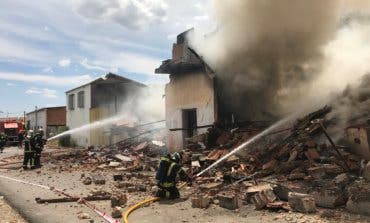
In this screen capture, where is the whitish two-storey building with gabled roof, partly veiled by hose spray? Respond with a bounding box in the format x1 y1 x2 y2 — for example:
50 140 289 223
66 73 146 147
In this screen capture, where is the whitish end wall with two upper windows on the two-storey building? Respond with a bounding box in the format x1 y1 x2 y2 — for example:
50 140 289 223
66 85 91 147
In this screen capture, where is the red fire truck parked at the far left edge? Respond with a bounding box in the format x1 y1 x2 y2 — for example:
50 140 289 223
0 118 25 145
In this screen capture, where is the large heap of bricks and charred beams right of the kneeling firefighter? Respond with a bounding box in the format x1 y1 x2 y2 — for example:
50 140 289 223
185 107 370 215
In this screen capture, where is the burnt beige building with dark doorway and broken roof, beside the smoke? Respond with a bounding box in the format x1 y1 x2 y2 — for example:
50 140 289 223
155 31 218 150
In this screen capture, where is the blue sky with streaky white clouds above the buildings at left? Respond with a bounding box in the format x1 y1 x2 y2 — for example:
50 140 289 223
0 0 215 117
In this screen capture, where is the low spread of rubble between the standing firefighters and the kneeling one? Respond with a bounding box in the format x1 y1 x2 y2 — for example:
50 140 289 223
49 135 167 171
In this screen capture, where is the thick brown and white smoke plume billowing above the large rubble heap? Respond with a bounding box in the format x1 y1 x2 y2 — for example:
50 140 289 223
190 0 370 120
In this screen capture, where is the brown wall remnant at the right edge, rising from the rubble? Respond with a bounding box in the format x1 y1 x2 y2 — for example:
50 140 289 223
346 127 370 160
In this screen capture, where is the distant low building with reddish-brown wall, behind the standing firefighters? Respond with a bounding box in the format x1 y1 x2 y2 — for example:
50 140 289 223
26 106 66 138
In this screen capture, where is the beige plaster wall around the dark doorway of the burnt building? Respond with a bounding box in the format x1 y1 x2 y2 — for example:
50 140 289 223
165 71 216 151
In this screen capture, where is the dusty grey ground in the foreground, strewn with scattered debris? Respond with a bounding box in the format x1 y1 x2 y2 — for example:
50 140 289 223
0 147 370 223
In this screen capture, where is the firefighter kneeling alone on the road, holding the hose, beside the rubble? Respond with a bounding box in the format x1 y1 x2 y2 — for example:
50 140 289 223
156 152 191 199
